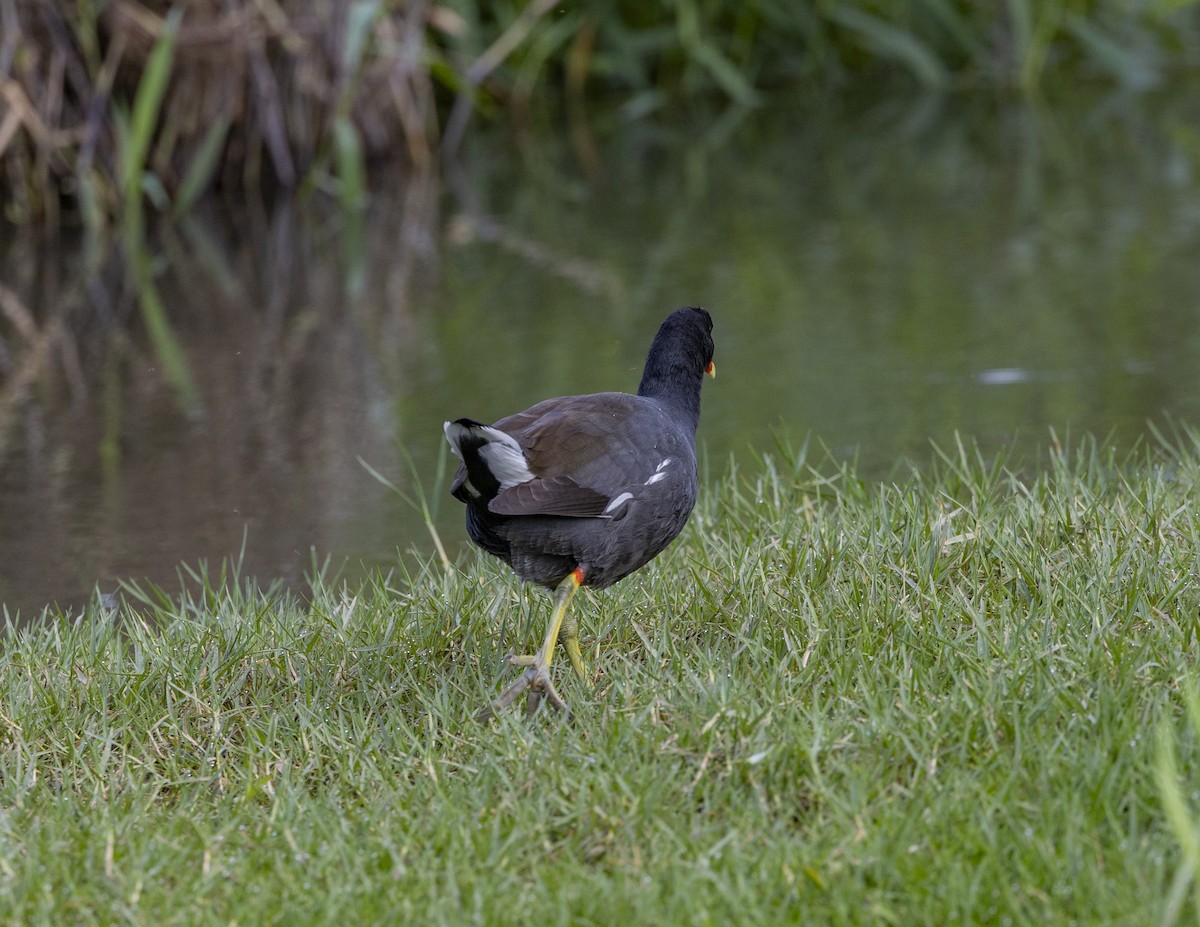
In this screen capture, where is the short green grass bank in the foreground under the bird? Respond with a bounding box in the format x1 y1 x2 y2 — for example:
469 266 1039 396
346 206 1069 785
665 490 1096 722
0 435 1200 925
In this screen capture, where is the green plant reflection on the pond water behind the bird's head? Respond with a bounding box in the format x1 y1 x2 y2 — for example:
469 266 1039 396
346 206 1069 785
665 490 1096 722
429 89 1200 472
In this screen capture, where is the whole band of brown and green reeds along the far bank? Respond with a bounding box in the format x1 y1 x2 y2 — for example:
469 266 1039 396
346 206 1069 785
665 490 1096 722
0 0 1200 228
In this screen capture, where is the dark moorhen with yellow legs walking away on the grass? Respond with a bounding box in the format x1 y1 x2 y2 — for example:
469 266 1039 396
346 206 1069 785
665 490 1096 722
443 306 716 720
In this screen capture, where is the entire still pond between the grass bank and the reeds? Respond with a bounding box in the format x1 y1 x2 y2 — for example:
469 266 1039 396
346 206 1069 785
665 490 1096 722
0 89 1200 616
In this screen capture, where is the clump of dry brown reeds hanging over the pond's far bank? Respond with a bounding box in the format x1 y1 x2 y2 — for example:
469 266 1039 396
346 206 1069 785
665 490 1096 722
0 0 436 220
